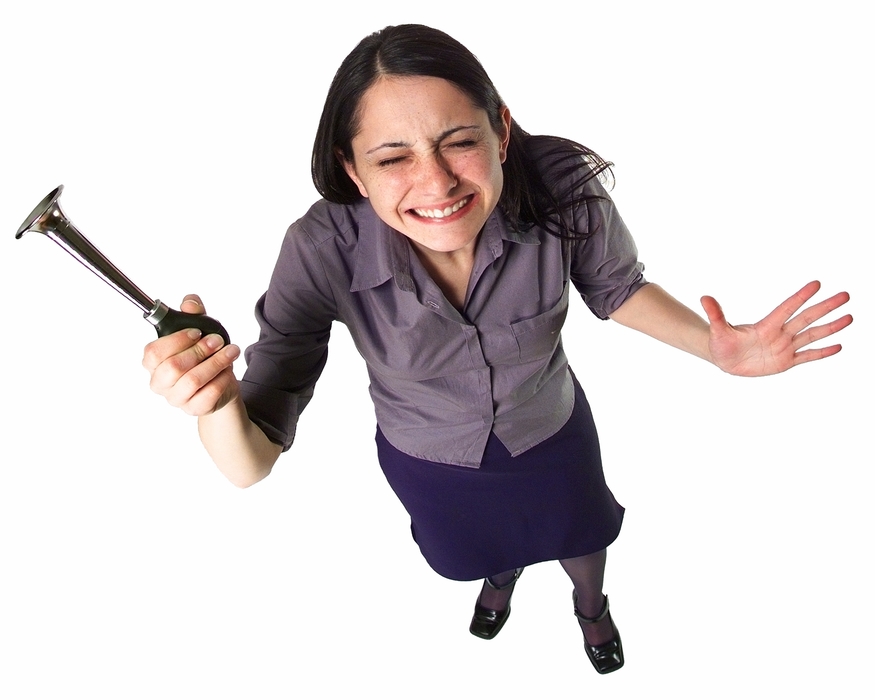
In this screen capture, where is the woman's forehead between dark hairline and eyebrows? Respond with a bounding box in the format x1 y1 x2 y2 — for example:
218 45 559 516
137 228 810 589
354 76 489 140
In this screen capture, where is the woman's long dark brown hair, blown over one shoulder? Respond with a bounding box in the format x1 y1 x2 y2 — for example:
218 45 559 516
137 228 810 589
311 24 611 238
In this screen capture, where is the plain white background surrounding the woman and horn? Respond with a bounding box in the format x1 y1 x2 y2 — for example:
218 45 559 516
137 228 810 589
0 0 875 700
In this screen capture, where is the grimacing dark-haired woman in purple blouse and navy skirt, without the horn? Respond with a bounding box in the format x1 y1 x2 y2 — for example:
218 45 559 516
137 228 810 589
144 25 851 673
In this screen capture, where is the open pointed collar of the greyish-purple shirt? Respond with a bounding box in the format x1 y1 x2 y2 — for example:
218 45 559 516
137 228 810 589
349 199 540 292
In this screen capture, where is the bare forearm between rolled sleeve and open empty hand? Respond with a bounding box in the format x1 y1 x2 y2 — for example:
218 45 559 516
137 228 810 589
611 284 712 362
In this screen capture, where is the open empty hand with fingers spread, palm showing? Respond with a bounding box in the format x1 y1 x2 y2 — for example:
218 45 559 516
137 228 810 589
702 282 853 377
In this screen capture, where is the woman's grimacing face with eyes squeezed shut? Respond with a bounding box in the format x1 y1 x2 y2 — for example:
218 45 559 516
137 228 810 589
339 76 510 253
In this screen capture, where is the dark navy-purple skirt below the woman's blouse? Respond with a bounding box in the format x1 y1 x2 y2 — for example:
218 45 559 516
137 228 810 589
376 372 624 581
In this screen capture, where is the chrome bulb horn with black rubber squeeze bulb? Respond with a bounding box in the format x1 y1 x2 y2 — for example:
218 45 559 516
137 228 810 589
15 185 231 345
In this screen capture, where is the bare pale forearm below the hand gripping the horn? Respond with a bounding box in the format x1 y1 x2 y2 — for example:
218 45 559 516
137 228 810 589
198 396 282 488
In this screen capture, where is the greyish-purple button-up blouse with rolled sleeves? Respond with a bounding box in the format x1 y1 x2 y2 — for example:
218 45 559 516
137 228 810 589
241 139 646 468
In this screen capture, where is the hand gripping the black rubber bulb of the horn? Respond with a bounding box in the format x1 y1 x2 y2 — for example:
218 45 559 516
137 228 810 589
143 294 240 416
